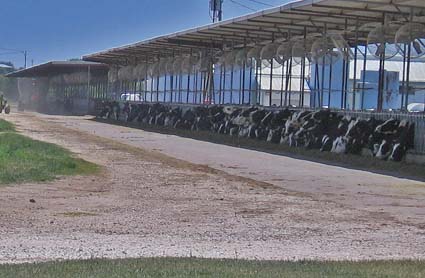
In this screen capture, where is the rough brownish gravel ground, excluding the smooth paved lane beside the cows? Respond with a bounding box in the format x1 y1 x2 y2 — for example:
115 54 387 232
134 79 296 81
0 114 425 263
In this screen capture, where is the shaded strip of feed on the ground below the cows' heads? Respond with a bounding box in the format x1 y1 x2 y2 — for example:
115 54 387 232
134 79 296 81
96 119 425 180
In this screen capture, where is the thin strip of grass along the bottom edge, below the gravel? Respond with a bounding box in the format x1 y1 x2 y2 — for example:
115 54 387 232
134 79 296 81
0 258 425 278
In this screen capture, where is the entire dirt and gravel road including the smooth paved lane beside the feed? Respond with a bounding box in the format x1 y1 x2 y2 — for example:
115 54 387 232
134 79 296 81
0 113 425 262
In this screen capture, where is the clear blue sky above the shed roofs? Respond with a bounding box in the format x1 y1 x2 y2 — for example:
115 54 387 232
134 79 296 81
0 0 289 67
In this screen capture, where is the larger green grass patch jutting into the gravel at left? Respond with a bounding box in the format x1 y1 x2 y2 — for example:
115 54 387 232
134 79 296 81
0 132 98 185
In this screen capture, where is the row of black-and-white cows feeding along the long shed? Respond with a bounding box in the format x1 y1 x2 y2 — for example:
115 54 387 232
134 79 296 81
98 102 414 161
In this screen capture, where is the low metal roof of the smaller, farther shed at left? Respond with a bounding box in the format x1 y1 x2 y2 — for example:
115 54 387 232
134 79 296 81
6 61 109 77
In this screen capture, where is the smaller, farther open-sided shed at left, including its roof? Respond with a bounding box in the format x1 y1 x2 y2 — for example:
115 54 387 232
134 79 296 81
6 61 109 113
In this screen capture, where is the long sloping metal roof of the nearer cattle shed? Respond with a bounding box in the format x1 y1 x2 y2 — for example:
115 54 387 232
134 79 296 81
83 0 425 64
